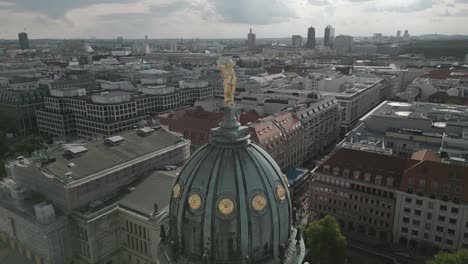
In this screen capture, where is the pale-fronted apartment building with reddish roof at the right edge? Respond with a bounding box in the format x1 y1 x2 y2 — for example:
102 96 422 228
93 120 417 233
393 155 468 254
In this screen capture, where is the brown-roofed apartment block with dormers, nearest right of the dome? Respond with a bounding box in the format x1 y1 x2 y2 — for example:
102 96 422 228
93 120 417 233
309 148 414 241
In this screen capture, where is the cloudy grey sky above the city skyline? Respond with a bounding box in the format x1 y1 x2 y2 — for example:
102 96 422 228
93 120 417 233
0 0 468 38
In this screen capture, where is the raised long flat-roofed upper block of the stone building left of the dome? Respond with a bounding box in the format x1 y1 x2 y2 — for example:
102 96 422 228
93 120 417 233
7 128 190 211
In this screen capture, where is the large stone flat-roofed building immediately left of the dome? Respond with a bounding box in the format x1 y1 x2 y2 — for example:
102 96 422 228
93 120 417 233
0 127 190 264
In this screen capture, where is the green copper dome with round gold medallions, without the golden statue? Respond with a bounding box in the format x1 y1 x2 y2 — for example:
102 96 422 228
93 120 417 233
159 107 303 264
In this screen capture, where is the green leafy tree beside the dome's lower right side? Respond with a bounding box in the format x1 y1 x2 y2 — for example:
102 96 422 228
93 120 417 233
305 216 347 264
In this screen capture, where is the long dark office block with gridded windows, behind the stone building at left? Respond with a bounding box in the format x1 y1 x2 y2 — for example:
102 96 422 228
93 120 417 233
37 79 213 139
